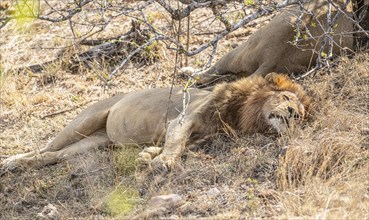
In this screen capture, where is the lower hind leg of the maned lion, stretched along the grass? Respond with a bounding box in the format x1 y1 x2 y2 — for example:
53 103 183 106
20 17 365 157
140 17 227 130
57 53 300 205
2 129 110 170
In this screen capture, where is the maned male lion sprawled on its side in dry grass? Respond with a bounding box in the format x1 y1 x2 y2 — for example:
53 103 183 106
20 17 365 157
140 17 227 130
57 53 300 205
2 73 311 170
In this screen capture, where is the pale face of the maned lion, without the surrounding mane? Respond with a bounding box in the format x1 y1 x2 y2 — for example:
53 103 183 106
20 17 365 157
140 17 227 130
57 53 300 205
263 91 305 133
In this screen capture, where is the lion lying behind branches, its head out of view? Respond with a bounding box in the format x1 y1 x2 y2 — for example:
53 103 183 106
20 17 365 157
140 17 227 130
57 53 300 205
196 0 354 85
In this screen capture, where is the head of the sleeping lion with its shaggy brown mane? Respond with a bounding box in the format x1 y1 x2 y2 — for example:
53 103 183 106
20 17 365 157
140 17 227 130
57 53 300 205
210 73 311 133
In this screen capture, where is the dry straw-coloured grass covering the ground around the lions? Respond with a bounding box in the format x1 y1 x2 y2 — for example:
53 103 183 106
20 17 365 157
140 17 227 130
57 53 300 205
0 0 369 219
